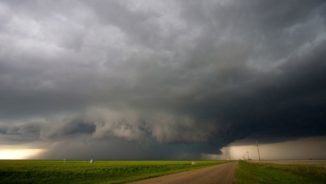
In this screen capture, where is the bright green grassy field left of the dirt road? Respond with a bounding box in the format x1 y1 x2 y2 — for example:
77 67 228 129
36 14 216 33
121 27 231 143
0 160 226 184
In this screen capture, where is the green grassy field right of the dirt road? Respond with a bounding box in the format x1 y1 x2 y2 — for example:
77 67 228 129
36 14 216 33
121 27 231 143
235 161 326 184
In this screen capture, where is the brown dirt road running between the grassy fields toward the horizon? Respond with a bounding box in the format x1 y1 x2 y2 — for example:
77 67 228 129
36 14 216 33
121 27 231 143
132 162 237 184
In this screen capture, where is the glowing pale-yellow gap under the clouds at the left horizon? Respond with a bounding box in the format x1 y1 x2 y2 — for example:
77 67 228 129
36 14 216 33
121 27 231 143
0 148 45 160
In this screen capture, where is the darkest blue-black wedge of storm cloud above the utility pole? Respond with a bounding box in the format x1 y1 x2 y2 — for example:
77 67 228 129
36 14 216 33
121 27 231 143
200 40 326 142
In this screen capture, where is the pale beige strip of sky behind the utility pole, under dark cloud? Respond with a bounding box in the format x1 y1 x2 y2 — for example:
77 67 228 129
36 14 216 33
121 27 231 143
219 136 326 160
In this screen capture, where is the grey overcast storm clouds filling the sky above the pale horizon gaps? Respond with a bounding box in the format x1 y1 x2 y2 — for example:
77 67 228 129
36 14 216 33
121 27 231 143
0 0 326 159
